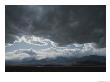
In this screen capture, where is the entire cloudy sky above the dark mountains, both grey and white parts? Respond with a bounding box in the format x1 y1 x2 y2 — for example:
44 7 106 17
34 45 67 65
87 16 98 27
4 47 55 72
5 5 106 63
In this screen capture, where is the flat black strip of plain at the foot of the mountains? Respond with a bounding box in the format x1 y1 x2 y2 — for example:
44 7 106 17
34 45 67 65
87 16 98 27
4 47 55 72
5 65 106 72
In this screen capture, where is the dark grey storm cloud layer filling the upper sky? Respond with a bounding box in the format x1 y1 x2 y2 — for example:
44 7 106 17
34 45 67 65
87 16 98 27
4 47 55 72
5 5 106 47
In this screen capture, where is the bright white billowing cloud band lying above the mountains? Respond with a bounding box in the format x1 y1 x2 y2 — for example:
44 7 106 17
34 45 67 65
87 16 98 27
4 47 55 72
5 35 106 62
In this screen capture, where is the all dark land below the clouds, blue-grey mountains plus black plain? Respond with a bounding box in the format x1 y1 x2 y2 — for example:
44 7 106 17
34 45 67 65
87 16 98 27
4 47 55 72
5 56 106 72
